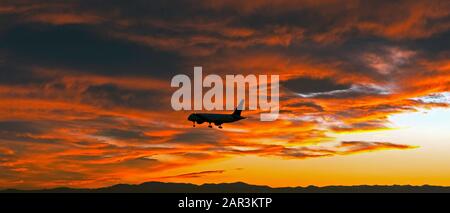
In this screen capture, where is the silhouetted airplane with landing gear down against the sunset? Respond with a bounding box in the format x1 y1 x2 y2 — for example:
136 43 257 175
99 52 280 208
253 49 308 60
188 100 245 129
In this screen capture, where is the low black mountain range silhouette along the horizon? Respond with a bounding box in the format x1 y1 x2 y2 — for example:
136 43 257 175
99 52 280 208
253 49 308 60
0 182 450 193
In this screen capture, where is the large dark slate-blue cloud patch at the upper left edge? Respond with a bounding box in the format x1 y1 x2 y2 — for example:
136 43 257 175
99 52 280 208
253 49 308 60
0 24 179 77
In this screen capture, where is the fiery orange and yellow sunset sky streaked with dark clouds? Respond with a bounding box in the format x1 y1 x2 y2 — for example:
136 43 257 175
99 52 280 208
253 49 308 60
0 0 450 189
